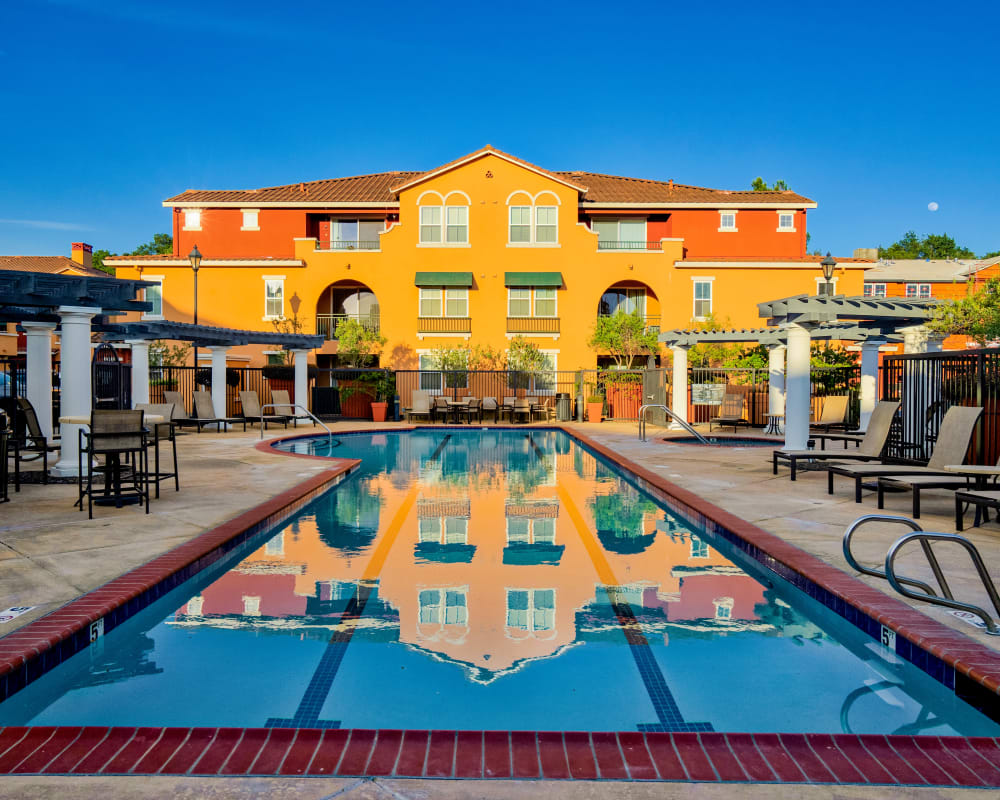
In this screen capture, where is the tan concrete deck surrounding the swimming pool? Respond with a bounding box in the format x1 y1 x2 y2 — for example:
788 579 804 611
0 423 997 797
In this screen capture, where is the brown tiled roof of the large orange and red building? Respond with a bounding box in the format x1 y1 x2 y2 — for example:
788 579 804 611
163 145 816 208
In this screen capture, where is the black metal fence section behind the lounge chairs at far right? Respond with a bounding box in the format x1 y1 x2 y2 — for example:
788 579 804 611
882 348 1000 464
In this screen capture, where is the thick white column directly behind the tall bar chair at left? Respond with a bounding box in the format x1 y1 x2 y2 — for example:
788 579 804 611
51 306 101 476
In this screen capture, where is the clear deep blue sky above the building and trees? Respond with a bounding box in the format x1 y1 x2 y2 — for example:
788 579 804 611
0 0 1000 255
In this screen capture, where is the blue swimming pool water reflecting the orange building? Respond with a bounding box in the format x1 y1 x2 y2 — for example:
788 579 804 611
0 428 1000 736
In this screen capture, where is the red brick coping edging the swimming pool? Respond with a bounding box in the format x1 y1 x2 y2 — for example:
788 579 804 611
0 425 1000 787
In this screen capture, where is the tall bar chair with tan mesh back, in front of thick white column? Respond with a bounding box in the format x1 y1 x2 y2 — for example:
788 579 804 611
77 408 149 519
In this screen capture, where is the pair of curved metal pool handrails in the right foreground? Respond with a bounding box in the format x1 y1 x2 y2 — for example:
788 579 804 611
844 514 1000 636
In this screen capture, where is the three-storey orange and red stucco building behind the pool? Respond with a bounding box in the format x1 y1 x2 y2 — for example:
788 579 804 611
106 146 870 370
